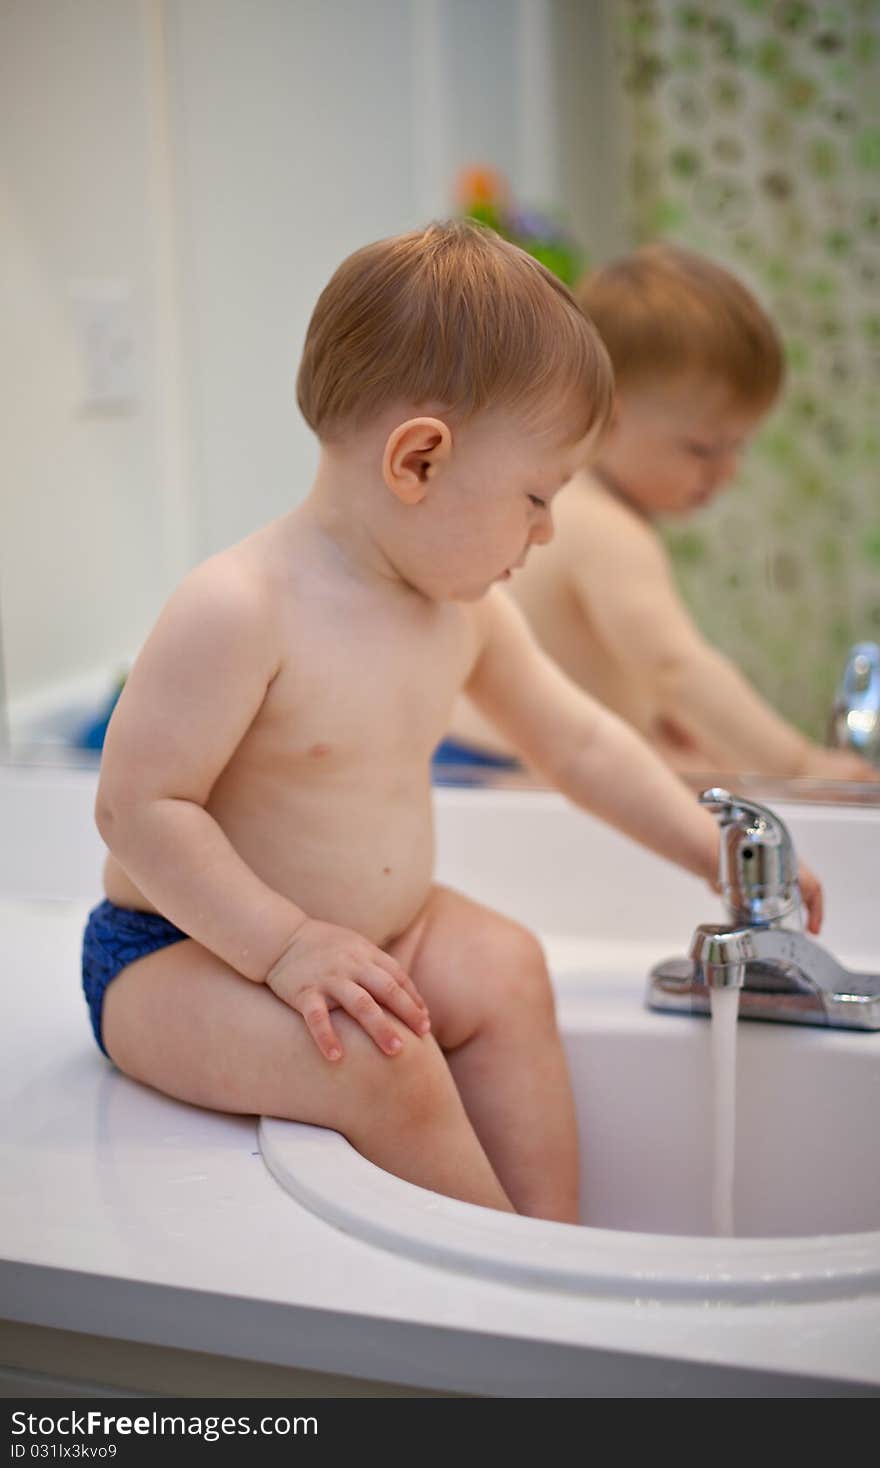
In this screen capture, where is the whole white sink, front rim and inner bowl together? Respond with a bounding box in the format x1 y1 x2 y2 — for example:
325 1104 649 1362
260 944 880 1302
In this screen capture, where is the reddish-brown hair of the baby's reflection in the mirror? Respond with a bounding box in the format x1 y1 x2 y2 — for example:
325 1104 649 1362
574 242 785 411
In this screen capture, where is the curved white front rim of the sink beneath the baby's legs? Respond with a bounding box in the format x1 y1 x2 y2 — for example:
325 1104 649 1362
257 1117 880 1304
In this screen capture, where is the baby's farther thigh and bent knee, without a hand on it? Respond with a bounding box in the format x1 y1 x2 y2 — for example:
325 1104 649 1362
388 885 555 1050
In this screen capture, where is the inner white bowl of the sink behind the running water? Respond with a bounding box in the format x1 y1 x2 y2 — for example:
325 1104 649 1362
563 974 880 1239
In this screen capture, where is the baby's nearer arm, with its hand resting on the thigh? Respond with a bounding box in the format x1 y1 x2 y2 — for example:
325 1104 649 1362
95 556 425 1058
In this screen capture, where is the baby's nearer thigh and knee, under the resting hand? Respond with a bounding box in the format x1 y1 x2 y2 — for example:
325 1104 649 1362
103 940 452 1136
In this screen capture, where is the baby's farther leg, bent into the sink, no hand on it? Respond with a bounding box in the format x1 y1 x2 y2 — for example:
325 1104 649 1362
389 887 579 1223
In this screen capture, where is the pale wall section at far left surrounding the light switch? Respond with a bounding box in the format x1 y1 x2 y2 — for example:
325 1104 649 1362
0 0 166 728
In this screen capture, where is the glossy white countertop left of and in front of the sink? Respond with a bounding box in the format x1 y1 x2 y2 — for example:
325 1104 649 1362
0 898 880 1398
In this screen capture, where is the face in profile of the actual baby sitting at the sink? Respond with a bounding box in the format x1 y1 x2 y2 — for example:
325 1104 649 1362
417 413 591 602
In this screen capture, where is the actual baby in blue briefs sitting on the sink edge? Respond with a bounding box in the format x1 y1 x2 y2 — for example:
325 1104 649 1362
84 222 820 1221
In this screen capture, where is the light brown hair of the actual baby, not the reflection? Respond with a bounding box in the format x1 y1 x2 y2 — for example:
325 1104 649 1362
297 220 614 442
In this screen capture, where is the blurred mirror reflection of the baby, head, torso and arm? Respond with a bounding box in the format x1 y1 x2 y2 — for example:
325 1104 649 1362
444 244 877 780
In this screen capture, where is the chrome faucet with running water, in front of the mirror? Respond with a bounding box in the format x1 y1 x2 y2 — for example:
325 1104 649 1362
646 788 880 1029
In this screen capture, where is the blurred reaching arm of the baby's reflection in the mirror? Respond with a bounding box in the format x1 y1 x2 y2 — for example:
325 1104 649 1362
563 502 876 780
